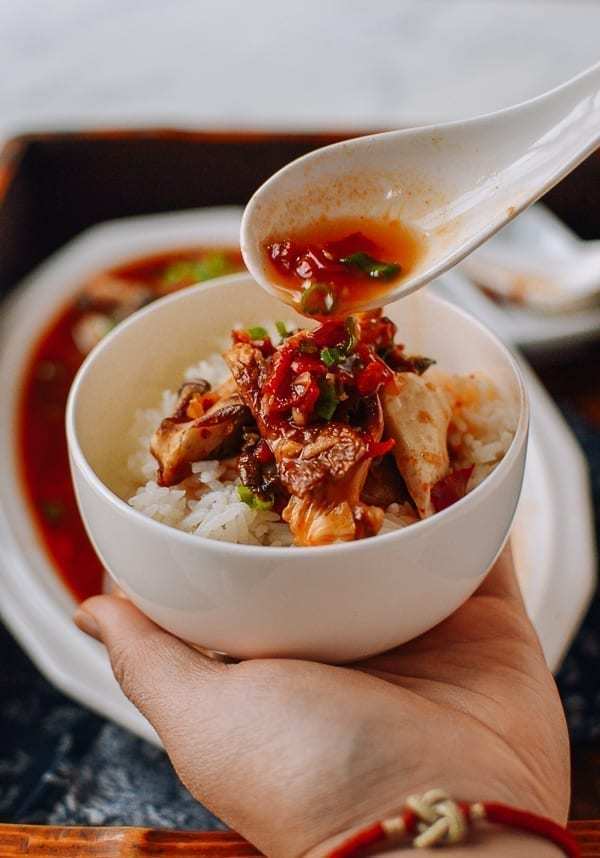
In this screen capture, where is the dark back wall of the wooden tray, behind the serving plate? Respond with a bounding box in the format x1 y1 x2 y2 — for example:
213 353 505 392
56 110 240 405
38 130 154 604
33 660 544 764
0 129 600 294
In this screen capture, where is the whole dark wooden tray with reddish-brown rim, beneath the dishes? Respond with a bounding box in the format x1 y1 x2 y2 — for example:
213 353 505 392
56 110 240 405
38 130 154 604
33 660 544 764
0 129 600 858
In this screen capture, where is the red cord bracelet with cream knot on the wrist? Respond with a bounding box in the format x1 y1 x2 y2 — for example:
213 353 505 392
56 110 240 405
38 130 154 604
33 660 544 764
327 789 581 858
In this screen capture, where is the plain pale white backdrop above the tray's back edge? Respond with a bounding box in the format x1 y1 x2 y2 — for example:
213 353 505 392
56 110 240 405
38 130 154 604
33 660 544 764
0 0 600 137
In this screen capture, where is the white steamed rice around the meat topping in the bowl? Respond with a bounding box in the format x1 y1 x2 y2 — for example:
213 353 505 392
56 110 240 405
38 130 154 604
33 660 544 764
127 348 517 546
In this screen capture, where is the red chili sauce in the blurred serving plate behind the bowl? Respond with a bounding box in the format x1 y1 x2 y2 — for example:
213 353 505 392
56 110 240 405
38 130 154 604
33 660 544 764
17 248 243 600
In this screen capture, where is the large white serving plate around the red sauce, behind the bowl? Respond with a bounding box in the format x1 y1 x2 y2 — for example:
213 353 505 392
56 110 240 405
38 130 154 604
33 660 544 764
0 209 595 742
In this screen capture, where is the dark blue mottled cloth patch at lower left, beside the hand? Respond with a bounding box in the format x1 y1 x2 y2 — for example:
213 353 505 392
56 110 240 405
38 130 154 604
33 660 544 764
0 626 223 829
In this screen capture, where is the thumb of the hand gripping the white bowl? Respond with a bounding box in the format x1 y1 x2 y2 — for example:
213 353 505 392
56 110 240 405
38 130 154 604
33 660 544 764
74 596 228 741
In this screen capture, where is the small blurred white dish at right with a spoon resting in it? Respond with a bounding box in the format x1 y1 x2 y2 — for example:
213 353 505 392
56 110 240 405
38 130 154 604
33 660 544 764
447 204 600 353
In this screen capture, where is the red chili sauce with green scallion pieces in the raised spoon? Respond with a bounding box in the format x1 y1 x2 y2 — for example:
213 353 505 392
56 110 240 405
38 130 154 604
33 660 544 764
264 218 423 318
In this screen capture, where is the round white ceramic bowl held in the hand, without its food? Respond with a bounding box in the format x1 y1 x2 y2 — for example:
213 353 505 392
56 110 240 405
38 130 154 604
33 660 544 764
67 274 528 662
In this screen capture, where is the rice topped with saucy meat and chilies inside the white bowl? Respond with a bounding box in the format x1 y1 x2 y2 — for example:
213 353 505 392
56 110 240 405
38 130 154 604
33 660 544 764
128 311 518 546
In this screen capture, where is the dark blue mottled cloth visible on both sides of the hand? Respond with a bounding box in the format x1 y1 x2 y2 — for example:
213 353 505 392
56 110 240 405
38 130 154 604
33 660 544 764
0 407 600 829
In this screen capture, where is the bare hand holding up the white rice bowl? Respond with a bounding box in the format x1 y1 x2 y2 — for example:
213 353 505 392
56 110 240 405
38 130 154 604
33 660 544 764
76 552 569 856
